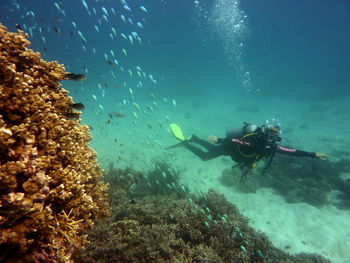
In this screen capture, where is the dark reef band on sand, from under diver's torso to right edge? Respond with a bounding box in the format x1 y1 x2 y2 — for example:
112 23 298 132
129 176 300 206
219 155 350 209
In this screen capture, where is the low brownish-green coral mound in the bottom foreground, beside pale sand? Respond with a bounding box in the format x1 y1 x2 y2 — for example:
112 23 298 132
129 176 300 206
73 165 330 263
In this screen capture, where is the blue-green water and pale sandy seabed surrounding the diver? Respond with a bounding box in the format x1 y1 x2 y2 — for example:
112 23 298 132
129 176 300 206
0 0 350 263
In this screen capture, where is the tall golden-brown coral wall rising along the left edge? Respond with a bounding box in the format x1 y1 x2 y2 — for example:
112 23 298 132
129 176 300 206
0 24 108 262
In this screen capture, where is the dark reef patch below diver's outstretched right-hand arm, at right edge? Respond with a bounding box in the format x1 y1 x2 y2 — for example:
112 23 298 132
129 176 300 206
260 156 350 208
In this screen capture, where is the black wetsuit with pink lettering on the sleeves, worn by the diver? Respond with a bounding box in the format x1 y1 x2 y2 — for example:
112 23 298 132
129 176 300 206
183 133 316 165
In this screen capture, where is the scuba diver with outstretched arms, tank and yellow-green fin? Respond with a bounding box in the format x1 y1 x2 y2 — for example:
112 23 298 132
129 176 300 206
168 119 326 182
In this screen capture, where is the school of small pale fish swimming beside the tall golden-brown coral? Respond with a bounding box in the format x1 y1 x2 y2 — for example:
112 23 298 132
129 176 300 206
0 0 177 159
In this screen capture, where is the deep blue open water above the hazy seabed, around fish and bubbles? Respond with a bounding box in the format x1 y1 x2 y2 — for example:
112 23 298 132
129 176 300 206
1 0 350 98
